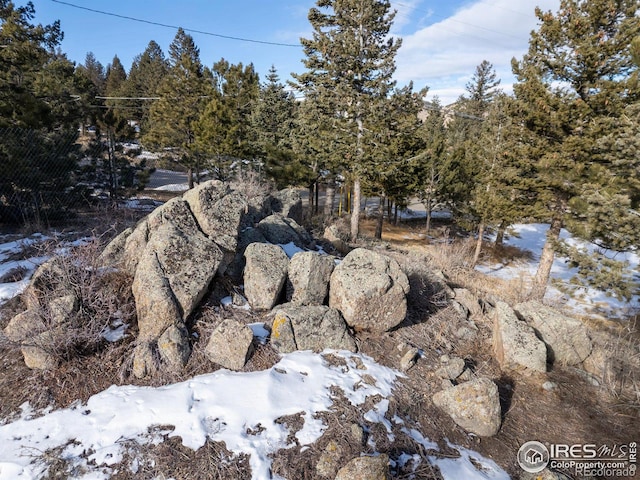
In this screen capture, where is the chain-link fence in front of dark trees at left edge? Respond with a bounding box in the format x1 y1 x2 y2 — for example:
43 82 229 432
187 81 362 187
0 128 148 226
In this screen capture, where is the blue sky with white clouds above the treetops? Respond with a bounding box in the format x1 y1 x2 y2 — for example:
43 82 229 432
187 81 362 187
31 0 559 104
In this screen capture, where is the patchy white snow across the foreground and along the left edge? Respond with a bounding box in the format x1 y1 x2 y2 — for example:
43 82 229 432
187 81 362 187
0 234 509 480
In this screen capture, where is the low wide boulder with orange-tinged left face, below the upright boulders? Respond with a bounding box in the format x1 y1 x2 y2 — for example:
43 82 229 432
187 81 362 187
271 303 356 353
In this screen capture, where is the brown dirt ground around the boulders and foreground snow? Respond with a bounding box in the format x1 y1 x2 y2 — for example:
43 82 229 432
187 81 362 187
0 208 640 479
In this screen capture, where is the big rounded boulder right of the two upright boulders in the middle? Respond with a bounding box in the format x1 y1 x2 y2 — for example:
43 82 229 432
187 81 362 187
329 248 409 332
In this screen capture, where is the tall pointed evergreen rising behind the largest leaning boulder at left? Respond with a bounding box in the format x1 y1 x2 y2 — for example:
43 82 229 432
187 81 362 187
142 29 211 188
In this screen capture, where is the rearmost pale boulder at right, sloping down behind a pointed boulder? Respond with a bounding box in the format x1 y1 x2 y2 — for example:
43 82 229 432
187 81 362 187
514 301 593 365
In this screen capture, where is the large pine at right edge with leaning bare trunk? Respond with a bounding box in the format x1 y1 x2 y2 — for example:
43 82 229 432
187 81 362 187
513 0 640 298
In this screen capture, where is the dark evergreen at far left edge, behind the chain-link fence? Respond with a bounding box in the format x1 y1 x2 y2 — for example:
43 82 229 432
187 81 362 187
0 0 83 221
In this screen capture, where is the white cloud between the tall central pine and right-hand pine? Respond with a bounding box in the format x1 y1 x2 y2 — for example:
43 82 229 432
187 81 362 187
395 0 559 104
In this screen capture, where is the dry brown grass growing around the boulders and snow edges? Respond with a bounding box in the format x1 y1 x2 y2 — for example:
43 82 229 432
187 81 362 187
0 211 640 480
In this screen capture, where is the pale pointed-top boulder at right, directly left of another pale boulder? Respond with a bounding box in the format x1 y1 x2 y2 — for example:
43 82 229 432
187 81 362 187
493 302 547 373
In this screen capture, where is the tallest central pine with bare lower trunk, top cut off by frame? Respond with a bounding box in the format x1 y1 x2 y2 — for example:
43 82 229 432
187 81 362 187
294 0 400 240
